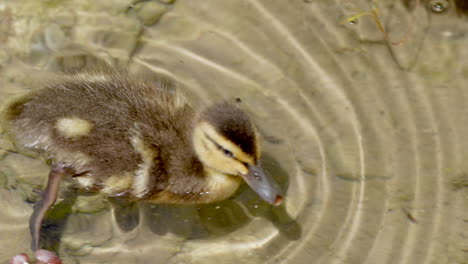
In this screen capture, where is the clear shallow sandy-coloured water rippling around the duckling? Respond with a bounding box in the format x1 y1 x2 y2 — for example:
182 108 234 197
0 0 468 263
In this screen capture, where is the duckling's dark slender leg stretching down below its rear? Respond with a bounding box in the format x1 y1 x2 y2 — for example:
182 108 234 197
29 164 73 252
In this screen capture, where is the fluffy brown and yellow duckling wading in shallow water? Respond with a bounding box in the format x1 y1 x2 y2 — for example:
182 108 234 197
5 71 283 252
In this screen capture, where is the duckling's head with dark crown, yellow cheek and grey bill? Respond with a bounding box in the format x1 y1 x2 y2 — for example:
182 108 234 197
193 103 283 205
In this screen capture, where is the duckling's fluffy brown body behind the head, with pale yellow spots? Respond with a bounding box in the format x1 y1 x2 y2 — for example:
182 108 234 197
7 72 193 197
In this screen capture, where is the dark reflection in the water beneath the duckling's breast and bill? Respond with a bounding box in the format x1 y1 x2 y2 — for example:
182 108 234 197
113 155 302 240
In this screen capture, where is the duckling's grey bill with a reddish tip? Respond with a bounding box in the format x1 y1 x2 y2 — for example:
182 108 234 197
242 165 283 205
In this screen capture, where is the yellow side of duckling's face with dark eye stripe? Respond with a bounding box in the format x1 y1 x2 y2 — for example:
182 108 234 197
193 122 255 175
